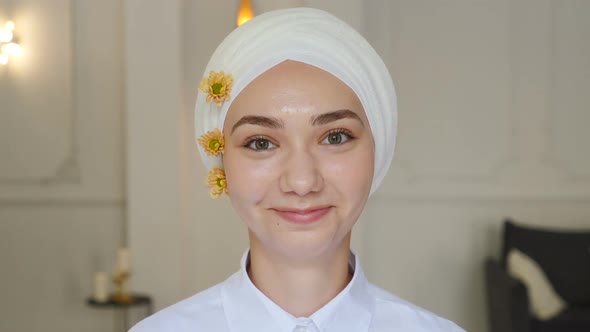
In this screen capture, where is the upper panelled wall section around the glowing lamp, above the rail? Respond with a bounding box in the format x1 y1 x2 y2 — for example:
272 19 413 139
0 0 125 202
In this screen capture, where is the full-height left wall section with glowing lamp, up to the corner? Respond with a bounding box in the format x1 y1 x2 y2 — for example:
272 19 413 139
0 0 125 332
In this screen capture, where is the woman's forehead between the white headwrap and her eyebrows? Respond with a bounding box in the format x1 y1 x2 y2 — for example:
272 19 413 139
226 60 366 122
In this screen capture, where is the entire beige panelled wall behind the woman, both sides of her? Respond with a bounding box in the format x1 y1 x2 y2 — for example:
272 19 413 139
0 0 590 332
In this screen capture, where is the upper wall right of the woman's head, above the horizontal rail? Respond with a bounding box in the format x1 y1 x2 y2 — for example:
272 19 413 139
364 0 590 200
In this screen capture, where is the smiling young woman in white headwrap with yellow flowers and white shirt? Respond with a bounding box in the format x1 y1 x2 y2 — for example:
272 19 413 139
131 8 463 332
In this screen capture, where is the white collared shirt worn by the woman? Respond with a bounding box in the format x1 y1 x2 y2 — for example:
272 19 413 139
129 251 465 332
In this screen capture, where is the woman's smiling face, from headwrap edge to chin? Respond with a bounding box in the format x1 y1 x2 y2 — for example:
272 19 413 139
223 61 374 259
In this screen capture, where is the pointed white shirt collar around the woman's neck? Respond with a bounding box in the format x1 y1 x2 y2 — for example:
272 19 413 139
222 250 373 332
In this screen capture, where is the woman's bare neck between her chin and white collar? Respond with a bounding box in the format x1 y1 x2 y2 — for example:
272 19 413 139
248 233 352 317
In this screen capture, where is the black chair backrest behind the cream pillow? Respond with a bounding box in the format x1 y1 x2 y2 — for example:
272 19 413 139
502 219 590 305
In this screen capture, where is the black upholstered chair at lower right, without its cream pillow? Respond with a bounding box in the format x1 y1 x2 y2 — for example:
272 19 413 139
485 219 590 332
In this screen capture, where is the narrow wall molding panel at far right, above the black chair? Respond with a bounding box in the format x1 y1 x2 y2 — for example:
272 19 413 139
543 0 590 183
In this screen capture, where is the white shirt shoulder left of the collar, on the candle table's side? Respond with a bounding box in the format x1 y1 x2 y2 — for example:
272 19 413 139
129 274 232 332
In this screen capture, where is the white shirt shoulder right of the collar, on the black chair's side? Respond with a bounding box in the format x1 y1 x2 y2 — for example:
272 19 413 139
367 283 465 332
